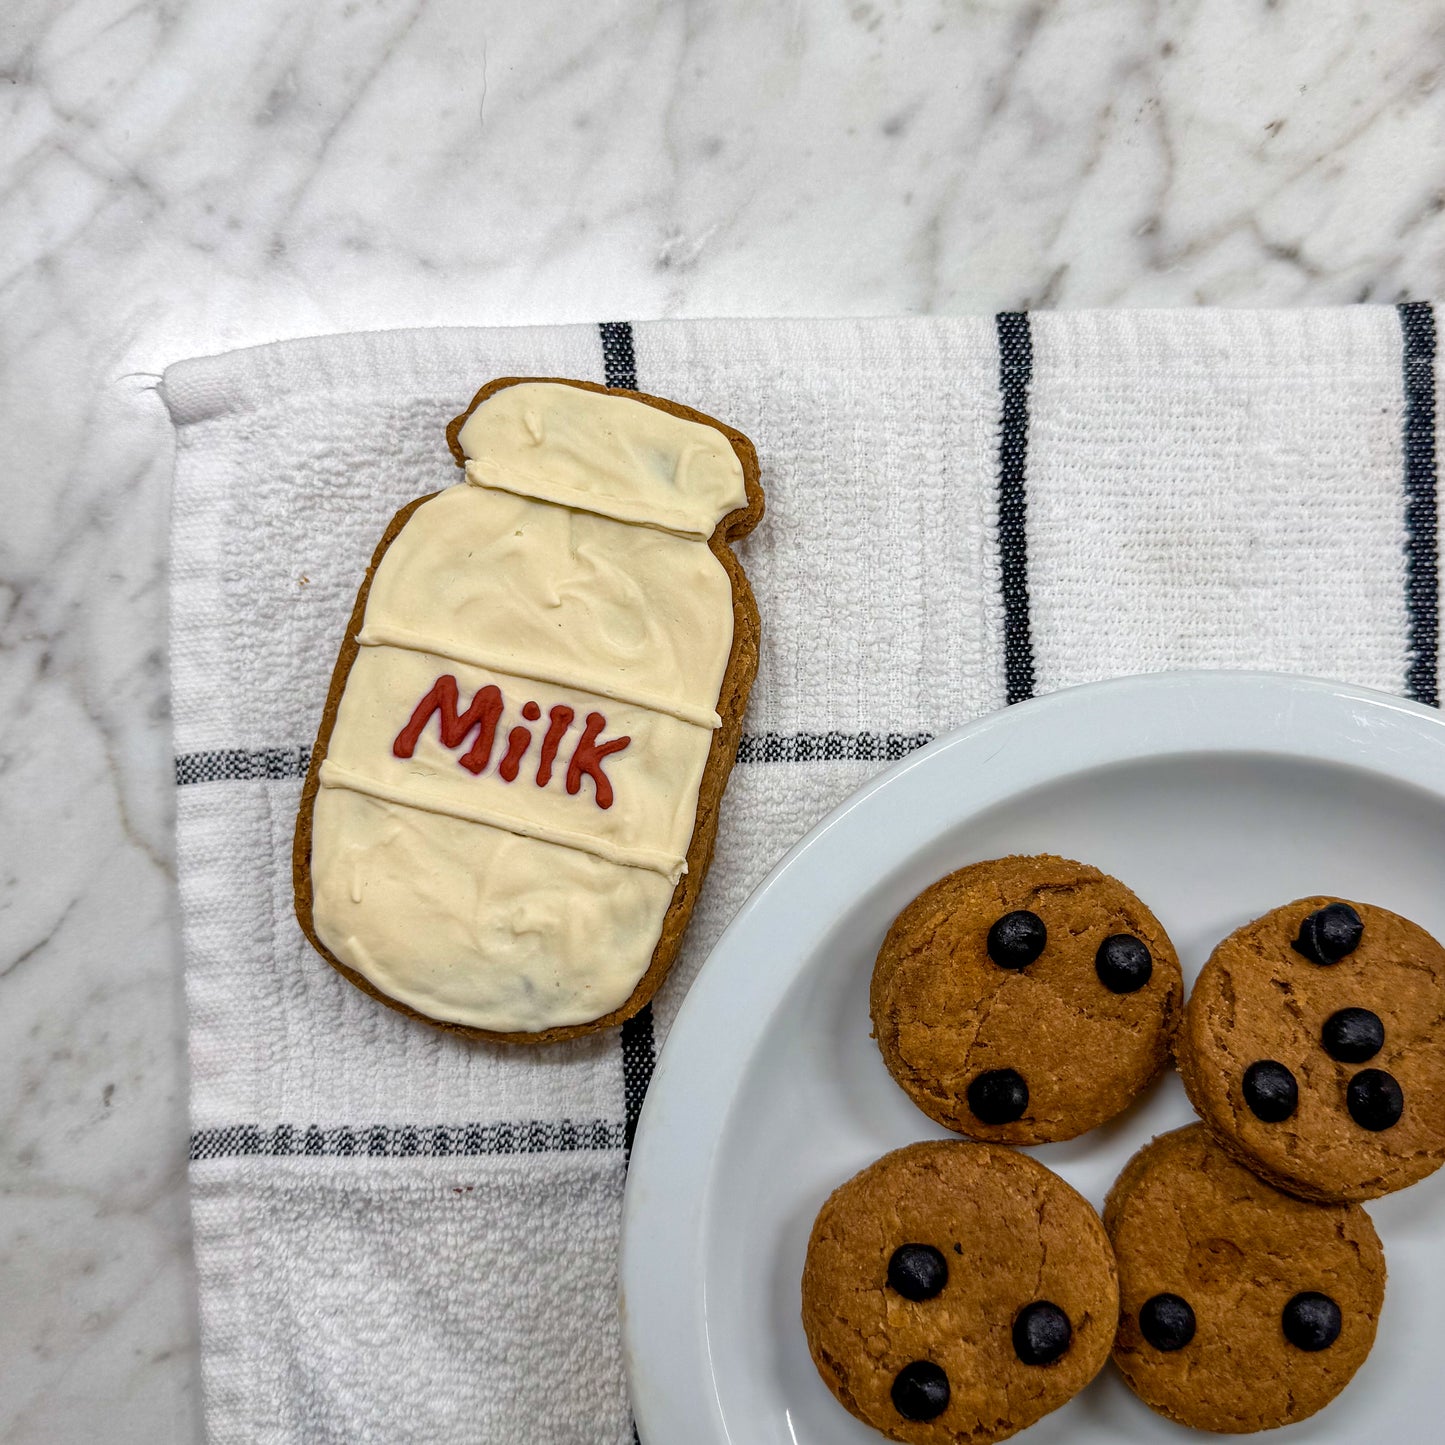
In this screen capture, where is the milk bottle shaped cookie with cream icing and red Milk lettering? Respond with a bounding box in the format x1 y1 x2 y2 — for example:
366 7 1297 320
295 379 763 1042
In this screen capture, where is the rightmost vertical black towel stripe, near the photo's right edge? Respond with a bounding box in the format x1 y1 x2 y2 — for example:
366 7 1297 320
1397 301 1441 707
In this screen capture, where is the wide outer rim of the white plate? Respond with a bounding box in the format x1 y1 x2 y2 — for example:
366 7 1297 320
618 670 1445 1445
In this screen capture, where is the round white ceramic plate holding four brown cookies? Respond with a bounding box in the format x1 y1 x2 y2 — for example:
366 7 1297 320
621 673 1445 1445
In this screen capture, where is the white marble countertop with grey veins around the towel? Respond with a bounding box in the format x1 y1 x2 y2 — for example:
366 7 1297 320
0 0 1445 1445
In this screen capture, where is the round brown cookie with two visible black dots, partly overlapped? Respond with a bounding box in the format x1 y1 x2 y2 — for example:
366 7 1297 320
1104 1124 1384 1435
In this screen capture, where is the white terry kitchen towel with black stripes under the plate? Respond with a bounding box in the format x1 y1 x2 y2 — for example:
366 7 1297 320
163 305 1442 1445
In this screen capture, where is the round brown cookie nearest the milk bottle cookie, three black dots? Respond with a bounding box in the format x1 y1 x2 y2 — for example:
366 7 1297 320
870 855 1183 1144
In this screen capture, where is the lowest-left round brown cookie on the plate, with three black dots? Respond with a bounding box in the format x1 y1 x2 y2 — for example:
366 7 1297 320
802 1140 1118 1445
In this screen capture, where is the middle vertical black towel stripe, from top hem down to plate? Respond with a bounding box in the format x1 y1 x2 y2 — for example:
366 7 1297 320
994 311 1033 702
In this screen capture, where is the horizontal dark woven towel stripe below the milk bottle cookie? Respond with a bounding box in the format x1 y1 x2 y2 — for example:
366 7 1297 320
191 1118 623 1159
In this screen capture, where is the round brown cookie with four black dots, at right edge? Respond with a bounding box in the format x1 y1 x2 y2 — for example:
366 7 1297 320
1179 897 1445 1199
